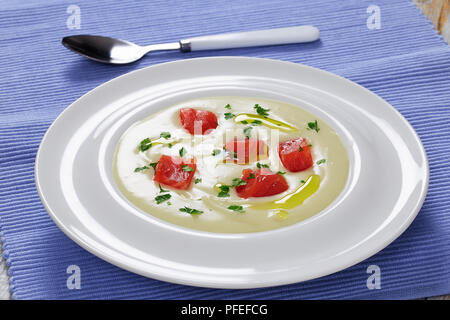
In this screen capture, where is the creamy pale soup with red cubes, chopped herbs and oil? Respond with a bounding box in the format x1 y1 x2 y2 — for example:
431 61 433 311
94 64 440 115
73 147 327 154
113 97 349 233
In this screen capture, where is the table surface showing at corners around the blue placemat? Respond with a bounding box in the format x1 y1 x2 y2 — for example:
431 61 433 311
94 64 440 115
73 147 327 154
0 0 450 300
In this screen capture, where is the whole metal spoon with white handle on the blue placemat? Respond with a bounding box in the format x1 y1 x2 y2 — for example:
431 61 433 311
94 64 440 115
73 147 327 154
62 26 319 64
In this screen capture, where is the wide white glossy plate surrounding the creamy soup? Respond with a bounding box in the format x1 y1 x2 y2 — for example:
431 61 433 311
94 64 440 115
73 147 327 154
35 57 429 288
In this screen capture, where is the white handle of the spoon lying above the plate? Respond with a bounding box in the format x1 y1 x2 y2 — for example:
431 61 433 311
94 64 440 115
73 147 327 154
180 26 320 51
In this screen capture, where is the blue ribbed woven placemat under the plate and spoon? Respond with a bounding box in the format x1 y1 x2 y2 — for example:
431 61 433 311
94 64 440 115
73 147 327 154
0 0 450 299
